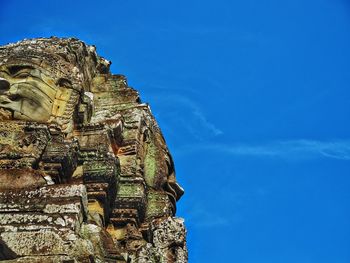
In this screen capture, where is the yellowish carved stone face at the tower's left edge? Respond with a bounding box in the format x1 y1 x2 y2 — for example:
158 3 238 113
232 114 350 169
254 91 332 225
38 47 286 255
0 65 59 122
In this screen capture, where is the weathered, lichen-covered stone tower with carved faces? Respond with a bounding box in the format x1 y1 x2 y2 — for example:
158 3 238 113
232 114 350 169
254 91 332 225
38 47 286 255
0 37 187 263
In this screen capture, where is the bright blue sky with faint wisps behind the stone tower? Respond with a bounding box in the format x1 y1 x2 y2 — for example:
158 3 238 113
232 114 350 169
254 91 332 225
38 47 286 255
0 0 350 263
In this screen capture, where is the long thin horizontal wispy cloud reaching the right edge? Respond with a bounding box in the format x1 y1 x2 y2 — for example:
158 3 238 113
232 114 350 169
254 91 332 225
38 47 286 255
174 139 350 160
